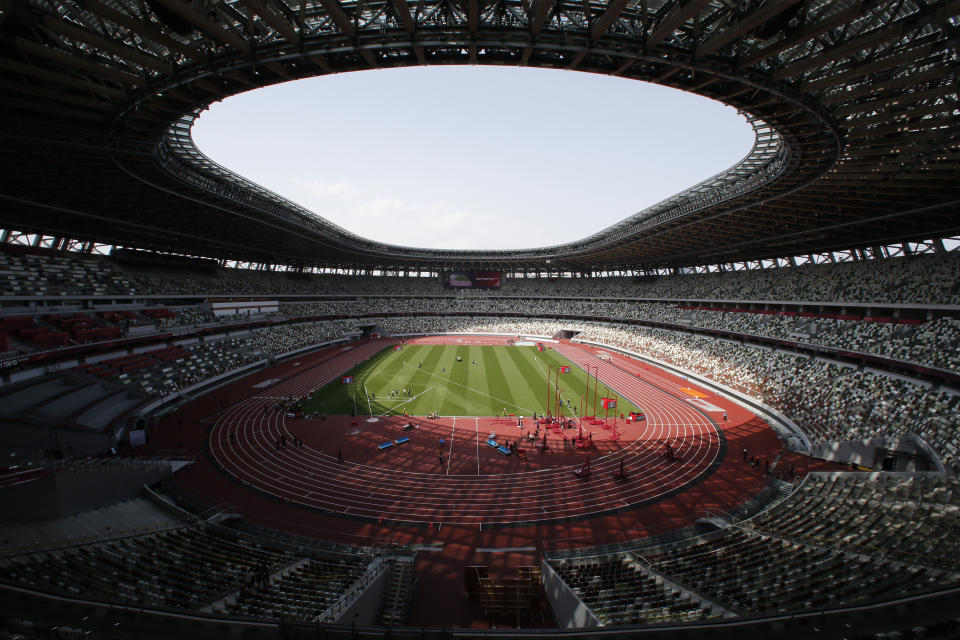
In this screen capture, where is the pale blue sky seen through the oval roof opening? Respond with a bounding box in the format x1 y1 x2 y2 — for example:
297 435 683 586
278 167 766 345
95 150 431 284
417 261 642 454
193 66 753 249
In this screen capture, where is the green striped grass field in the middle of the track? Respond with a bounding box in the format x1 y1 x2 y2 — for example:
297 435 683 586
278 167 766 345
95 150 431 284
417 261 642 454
303 345 636 416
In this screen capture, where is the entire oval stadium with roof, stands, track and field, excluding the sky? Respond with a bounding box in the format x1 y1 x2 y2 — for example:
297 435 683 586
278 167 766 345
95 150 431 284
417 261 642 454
0 0 960 639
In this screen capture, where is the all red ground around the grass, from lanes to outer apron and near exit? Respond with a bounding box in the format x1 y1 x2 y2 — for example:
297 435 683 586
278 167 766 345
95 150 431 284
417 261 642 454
145 336 840 626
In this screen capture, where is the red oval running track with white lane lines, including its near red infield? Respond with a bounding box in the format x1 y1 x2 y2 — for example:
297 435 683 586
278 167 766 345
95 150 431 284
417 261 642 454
209 338 724 529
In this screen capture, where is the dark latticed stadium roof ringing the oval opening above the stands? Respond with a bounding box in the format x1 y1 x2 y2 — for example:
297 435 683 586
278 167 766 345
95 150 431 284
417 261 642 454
0 0 960 271
